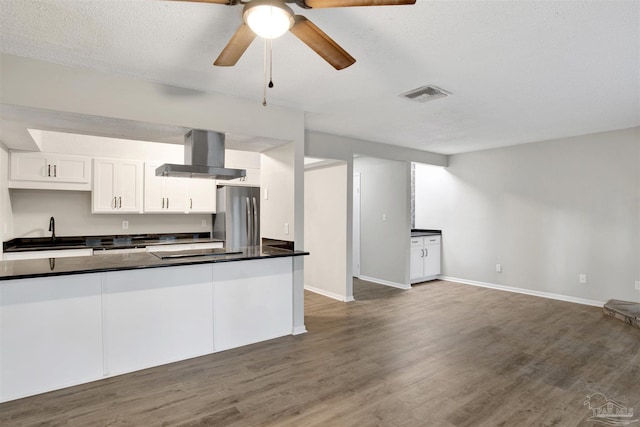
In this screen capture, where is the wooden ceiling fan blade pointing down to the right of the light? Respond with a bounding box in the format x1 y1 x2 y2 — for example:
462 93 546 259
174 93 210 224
290 15 356 70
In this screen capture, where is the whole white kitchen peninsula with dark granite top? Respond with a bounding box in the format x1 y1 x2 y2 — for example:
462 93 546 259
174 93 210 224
0 245 308 401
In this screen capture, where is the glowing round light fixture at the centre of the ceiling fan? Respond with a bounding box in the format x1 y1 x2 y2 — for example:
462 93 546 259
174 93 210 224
242 0 294 39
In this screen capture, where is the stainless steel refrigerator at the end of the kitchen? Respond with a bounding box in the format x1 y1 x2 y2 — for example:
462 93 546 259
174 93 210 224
213 185 260 251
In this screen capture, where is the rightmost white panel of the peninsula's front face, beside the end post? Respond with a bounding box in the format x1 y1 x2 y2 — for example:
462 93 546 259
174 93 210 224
213 258 293 351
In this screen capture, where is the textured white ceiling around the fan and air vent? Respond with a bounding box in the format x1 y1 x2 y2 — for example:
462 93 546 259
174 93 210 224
0 0 640 154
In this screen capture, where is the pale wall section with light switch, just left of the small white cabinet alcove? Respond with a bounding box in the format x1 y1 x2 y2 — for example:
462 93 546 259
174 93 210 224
353 157 411 288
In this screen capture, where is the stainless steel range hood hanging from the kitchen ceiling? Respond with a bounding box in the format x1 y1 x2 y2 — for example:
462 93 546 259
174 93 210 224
156 129 247 180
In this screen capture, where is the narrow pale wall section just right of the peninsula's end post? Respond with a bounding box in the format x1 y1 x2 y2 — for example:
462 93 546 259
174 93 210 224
304 163 353 301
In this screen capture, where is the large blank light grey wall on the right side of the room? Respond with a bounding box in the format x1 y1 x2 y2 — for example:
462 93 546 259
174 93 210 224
416 128 640 301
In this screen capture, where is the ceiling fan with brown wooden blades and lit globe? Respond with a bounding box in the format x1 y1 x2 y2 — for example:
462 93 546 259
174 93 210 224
166 0 416 70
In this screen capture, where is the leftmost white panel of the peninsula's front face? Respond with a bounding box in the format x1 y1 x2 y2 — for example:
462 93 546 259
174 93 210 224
0 274 104 401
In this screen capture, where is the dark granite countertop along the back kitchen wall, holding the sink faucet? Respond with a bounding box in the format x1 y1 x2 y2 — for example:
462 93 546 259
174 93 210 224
3 232 222 252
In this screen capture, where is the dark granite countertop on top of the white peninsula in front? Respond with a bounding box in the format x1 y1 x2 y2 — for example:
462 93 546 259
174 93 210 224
0 246 309 281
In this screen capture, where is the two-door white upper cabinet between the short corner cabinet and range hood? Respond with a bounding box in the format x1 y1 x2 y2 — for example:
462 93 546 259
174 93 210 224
91 159 144 213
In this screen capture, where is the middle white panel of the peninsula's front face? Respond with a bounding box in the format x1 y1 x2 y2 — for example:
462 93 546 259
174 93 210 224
104 264 213 375
